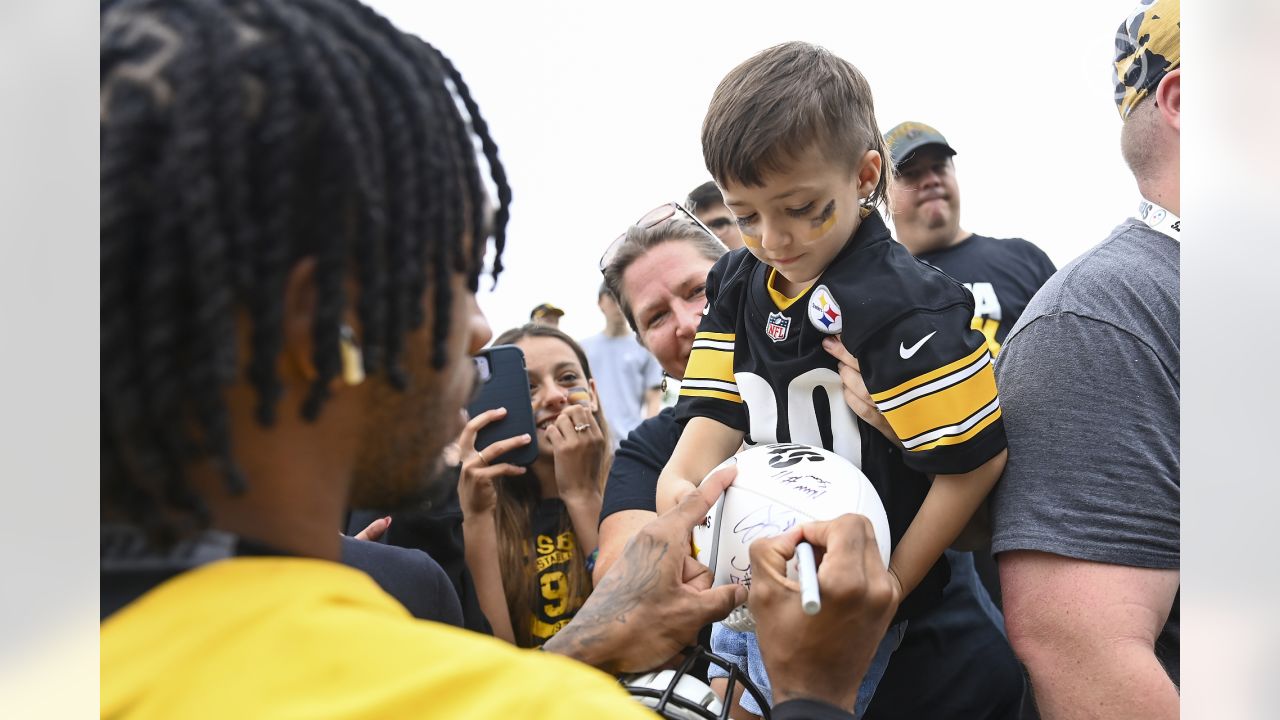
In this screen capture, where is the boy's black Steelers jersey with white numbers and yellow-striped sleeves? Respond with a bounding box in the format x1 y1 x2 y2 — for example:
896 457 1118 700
677 213 1005 476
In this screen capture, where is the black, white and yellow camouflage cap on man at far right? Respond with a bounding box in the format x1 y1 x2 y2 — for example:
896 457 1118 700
1112 0 1181 119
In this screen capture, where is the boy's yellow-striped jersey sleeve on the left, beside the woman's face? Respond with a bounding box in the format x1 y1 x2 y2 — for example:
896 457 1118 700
676 254 748 432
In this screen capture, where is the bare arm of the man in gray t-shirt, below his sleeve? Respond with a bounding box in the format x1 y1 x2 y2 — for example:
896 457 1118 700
1000 551 1179 720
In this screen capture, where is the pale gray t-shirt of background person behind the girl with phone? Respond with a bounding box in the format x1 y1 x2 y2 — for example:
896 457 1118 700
580 333 662 450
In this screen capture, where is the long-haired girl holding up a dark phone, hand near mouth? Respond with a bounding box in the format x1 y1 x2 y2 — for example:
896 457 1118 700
458 324 612 647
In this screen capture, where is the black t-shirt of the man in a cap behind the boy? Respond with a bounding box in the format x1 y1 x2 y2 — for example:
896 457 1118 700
918 234 1056 355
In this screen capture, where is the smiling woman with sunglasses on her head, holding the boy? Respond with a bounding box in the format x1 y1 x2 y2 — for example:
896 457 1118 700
595 202 1023 720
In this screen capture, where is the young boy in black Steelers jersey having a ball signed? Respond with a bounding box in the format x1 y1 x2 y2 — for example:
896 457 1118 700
658 42 1006 715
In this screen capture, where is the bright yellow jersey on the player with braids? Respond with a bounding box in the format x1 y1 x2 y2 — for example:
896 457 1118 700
101 557 653 720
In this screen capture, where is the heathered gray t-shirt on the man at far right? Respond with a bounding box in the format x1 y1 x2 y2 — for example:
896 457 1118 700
992 219 1180 684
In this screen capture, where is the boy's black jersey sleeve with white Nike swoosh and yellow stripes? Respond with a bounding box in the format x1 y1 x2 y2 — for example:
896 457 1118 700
858 304 1005 474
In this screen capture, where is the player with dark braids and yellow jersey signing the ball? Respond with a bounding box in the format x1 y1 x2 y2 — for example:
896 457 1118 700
100 0 895 719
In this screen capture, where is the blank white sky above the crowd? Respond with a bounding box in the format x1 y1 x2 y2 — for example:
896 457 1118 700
370 0 1138 337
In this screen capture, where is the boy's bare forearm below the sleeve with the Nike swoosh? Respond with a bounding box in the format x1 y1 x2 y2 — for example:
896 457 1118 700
888 450 1009 597
